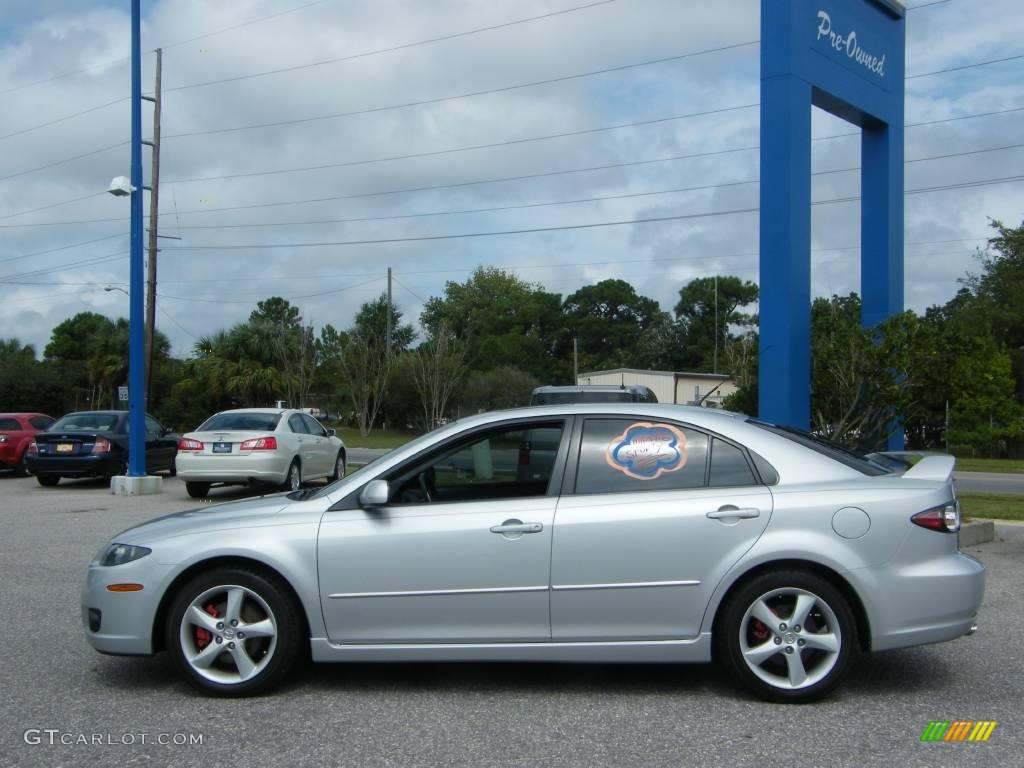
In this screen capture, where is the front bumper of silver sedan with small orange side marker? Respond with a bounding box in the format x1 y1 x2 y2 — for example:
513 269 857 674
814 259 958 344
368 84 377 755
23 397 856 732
82 554 170 656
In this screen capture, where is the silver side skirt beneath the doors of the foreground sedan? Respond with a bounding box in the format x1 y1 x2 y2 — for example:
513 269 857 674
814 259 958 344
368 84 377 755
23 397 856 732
309 632 712 664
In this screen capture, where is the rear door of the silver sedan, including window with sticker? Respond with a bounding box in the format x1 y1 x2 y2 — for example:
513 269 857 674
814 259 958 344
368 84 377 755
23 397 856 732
551 417 772 641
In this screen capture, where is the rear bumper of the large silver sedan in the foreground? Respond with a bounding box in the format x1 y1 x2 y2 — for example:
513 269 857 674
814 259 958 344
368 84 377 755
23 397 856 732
848 552 985 650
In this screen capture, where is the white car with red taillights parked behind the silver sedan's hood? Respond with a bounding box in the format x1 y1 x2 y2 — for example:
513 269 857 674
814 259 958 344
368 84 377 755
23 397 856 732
177 408 345 499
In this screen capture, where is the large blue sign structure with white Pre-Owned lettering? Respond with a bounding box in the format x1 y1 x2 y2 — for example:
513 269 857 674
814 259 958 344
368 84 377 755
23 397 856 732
759 0 905 450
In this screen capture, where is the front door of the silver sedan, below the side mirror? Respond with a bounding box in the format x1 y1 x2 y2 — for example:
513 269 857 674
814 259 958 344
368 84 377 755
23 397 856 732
317 418 568 643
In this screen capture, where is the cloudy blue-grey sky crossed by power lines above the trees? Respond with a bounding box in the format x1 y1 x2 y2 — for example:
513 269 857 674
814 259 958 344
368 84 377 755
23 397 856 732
0 0 1024 355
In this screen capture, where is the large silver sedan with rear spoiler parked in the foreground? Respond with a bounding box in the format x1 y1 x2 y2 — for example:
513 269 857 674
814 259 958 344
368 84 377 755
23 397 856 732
82 403 984 701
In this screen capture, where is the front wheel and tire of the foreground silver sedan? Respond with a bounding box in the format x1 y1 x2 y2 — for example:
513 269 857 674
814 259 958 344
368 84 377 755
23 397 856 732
165 567 308 696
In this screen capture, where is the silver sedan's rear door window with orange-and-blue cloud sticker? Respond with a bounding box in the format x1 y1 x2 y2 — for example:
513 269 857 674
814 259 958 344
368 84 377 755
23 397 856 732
575 419 708 494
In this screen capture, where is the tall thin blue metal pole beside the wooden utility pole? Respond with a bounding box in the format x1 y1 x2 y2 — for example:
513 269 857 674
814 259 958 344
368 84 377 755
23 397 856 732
128 0 145 477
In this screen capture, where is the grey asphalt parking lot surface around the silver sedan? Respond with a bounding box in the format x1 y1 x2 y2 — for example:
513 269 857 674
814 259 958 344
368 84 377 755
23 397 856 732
0 475 1024 768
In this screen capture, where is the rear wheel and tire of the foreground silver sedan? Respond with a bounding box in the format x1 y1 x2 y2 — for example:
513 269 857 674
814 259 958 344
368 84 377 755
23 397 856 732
715 570 857 703
